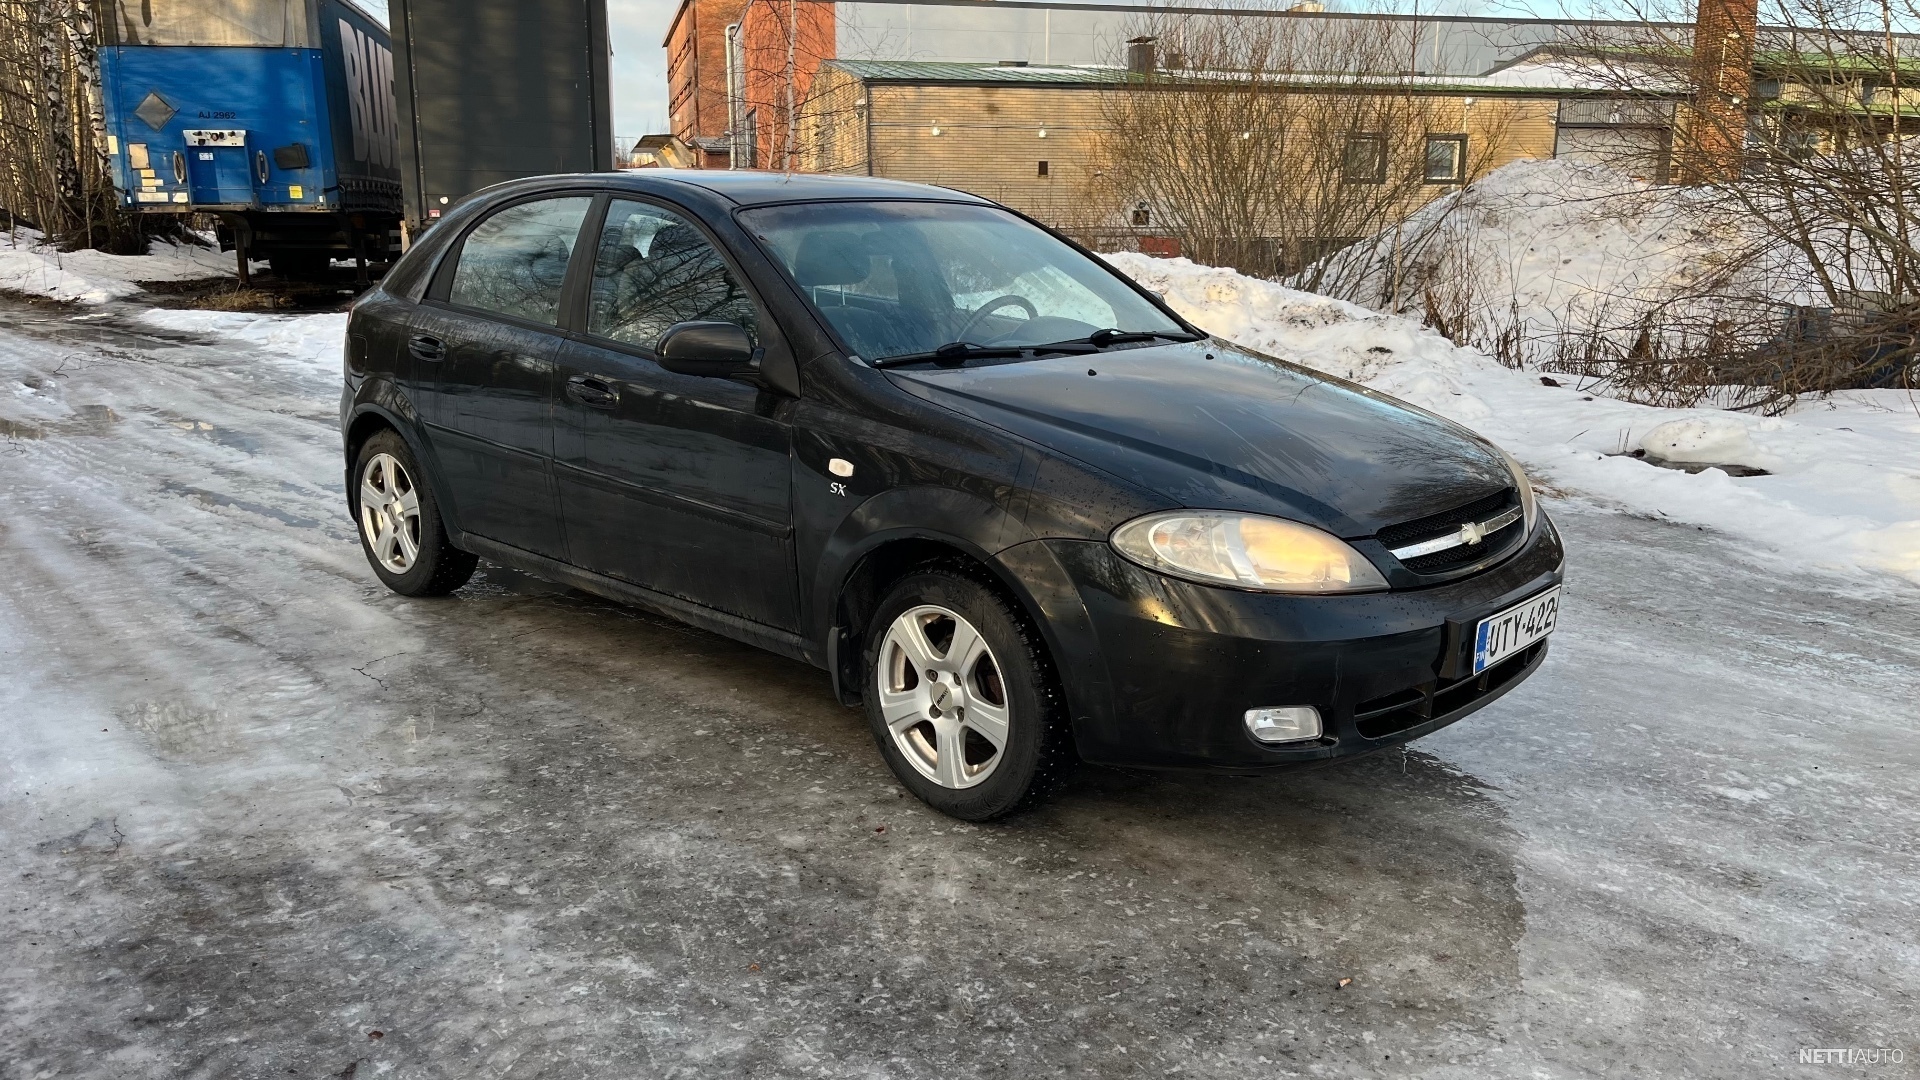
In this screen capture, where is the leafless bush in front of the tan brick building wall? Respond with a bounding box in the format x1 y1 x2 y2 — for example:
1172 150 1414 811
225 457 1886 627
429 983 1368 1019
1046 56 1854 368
1092 10 1513 288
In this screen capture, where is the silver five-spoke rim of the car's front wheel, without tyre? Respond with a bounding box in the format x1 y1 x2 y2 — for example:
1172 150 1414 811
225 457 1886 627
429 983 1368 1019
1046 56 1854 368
876 603 1012 790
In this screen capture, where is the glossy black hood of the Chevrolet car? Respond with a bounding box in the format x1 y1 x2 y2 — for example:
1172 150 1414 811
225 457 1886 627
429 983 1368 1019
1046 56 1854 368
887 340 1513 540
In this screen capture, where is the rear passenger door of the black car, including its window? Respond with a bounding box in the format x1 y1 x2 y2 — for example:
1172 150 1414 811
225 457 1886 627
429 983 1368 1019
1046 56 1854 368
407 194 593 559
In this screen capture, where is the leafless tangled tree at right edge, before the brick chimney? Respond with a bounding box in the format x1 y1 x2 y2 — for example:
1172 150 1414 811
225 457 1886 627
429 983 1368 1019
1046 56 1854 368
1543 0 1920 409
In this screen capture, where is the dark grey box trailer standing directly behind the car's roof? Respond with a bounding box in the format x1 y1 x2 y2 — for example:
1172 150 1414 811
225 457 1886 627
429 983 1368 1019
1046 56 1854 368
390 0 612 231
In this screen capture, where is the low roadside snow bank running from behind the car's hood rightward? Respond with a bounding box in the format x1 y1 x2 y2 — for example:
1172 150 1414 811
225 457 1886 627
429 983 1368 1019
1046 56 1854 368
1104 252 1920 580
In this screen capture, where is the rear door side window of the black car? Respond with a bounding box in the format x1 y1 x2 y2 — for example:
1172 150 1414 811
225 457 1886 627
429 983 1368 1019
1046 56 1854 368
447 196 593 327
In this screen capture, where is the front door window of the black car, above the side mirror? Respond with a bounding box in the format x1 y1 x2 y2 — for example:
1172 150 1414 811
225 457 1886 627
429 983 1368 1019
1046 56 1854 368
588 198 758 350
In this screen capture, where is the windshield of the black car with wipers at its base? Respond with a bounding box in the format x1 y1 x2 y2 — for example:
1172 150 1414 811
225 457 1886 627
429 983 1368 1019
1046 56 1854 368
741 202 1190 361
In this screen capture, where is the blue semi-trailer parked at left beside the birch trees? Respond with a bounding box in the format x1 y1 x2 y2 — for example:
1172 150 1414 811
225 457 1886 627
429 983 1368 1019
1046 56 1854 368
96 0 401 277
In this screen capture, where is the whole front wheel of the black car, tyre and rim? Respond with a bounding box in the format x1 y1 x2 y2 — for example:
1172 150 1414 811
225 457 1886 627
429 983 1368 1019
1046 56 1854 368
864 569 1069 821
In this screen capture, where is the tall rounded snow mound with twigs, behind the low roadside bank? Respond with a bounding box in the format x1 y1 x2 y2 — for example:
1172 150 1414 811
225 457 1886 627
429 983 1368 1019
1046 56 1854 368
1296 160 1820 365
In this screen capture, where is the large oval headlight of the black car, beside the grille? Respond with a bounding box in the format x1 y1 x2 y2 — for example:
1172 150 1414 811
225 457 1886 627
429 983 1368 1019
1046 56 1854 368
1114 509 1386 592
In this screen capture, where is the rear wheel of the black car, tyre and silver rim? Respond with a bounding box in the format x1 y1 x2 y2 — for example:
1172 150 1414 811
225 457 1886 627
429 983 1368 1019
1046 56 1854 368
353 429 480 596
